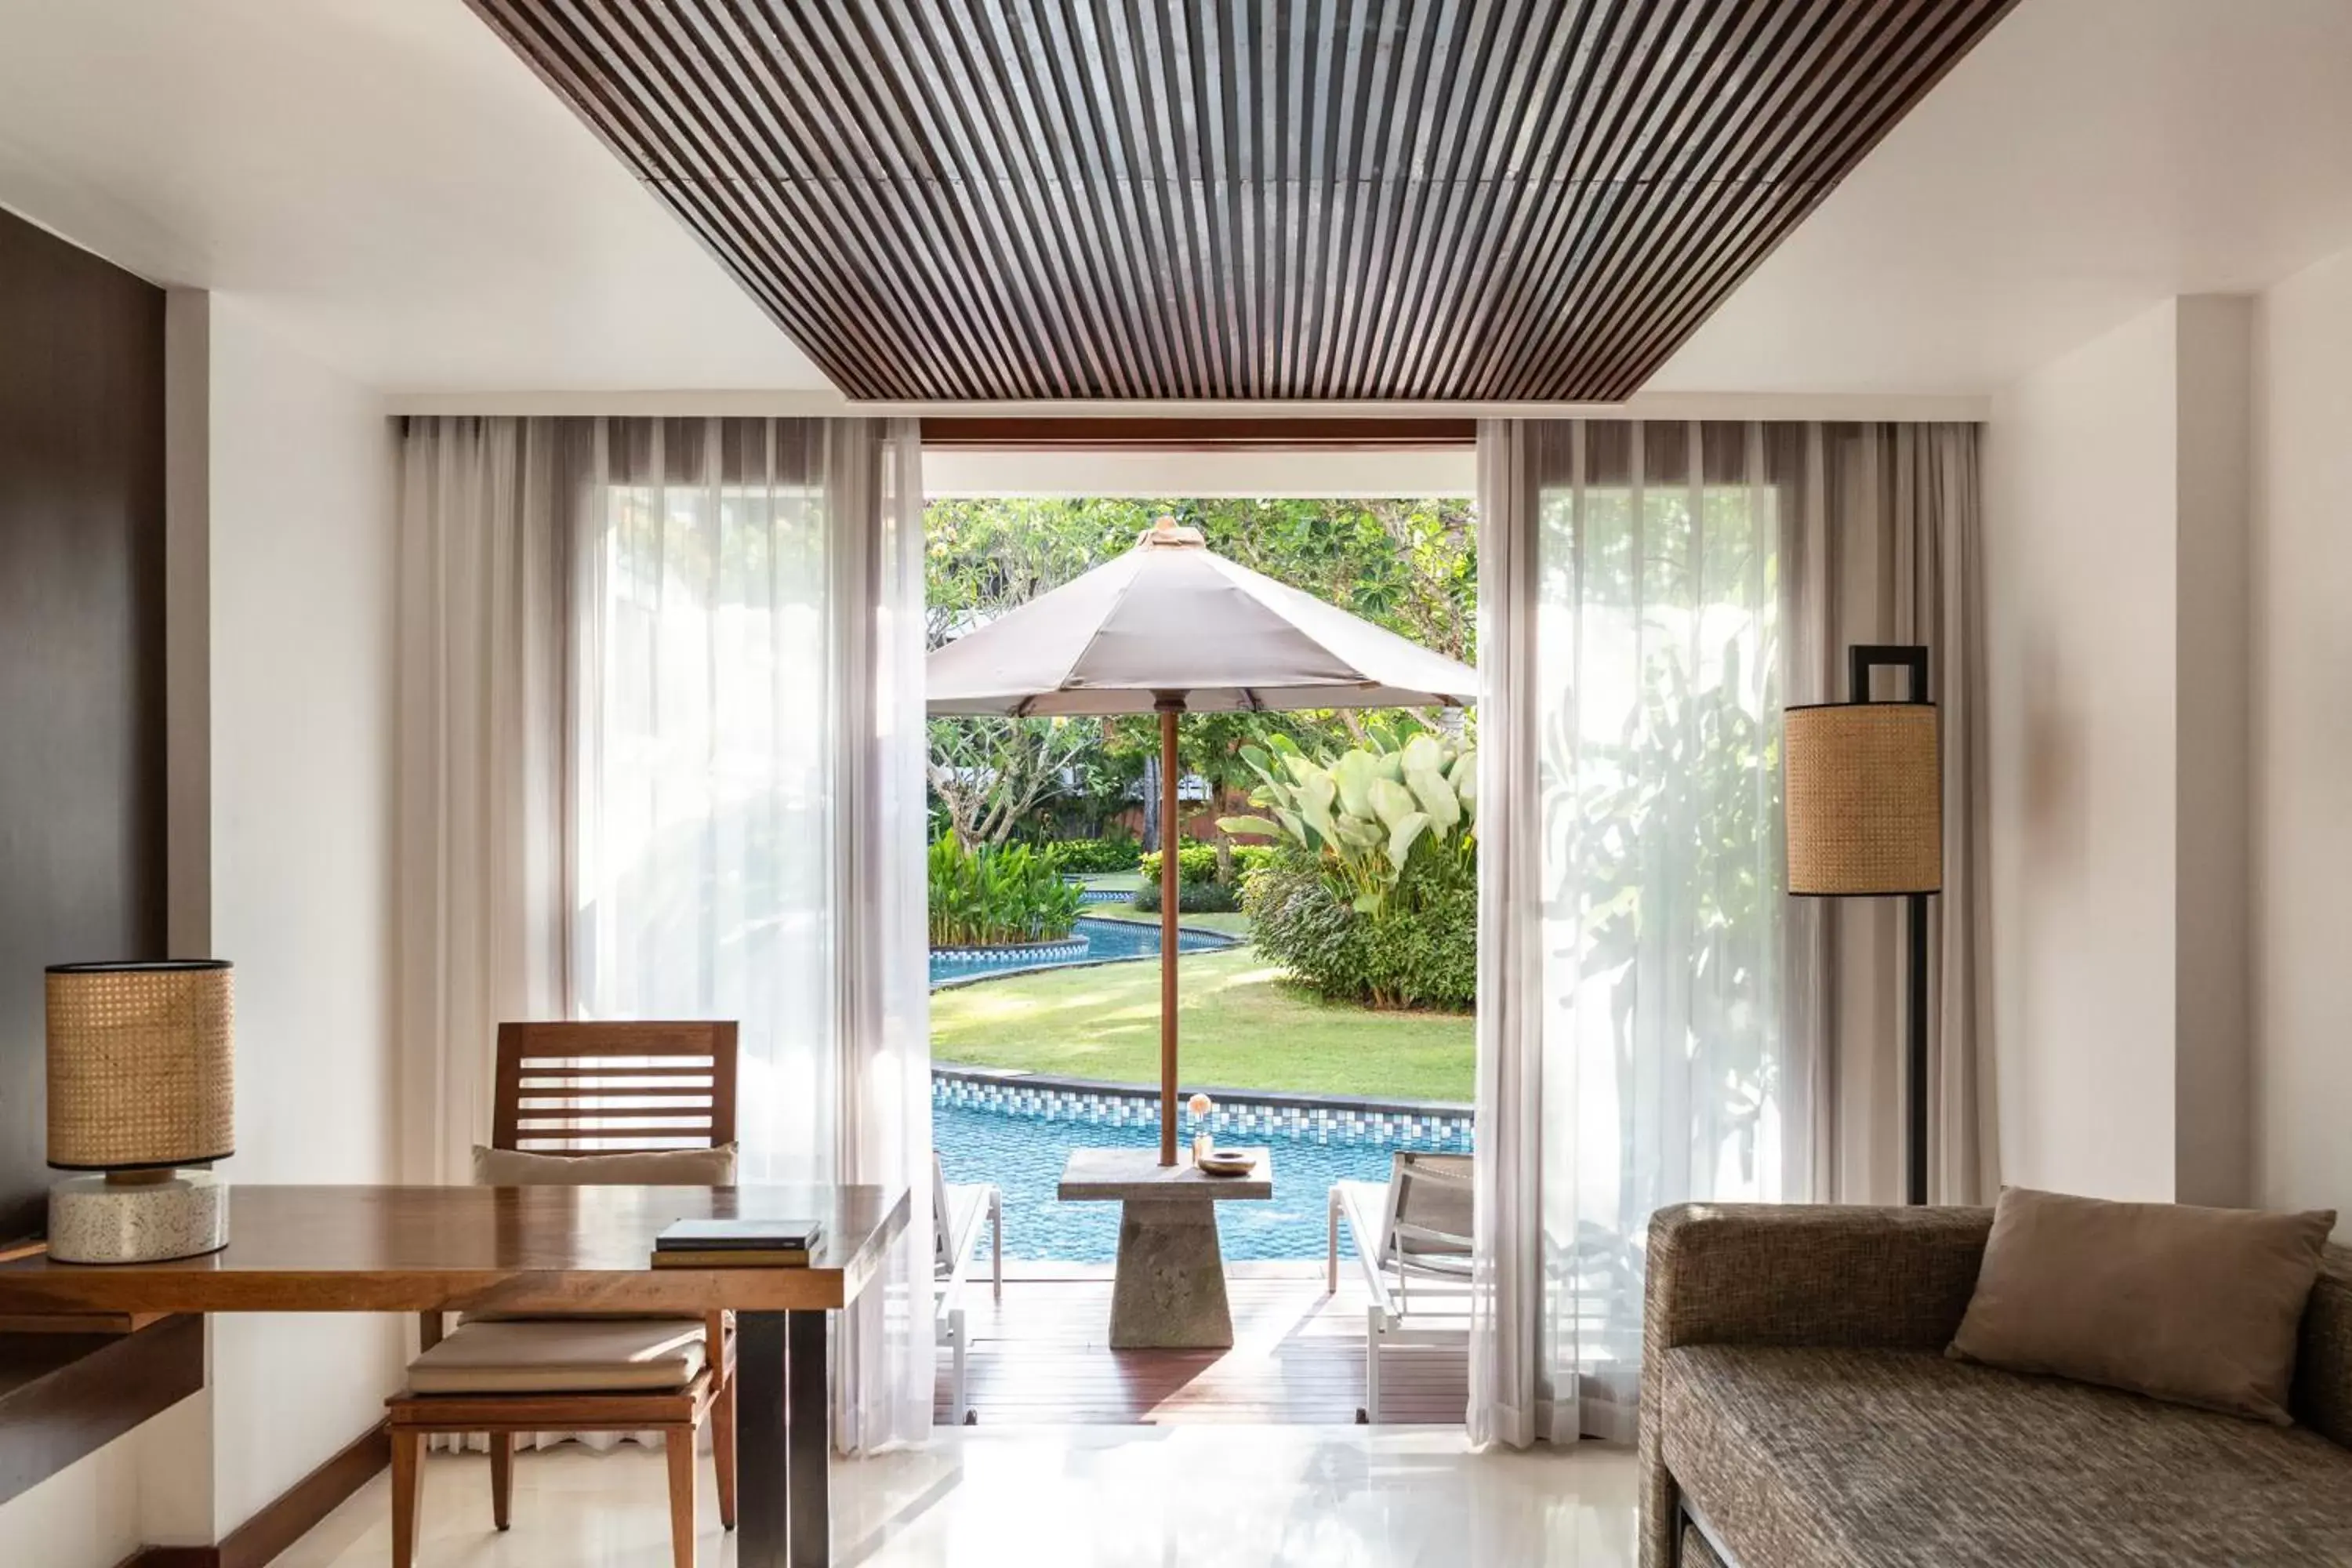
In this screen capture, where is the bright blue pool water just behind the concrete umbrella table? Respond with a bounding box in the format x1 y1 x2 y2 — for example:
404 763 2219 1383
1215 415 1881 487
931 1100 1430 1262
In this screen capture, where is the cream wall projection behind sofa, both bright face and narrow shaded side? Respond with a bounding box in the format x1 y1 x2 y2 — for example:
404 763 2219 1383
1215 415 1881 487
1985 296 2253 1203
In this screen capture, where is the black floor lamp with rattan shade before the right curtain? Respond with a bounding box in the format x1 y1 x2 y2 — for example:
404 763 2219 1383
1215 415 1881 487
1783 644 1943 1203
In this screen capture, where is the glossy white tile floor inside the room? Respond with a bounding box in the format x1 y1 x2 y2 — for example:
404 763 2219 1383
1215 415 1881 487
278 1427 1635 1568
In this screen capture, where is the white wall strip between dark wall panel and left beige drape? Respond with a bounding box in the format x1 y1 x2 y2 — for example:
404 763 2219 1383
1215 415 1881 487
209 296 402 1535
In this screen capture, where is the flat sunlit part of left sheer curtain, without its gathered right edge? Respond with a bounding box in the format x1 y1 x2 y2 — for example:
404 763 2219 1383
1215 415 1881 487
572 419 840 1182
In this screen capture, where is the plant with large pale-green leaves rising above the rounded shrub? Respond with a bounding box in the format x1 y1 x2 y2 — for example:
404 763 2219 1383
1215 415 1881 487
1218 727 1477 919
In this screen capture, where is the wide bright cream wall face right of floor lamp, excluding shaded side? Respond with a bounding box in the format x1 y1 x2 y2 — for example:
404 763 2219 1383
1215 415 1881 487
1985 303 2178 1199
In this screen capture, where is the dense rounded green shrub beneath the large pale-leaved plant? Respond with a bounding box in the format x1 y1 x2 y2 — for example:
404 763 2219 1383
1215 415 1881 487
1242 855 1477 1011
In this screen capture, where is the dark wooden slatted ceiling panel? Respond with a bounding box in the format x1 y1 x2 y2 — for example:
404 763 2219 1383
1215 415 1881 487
473 0 2013 402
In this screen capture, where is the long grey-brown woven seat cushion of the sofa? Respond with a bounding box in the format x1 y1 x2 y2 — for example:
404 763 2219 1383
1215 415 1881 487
1658 1345 2352 1568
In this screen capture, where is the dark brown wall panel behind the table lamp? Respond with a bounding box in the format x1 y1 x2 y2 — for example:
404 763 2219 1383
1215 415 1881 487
0 212 165 1241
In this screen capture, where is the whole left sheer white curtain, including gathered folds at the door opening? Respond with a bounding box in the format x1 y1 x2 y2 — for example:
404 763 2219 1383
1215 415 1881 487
572 419 934 1453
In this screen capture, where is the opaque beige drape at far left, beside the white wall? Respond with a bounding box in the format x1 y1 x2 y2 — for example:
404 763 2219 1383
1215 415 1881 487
395 419 586 1185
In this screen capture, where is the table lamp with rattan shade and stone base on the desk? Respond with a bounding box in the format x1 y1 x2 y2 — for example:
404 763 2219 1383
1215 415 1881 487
49 959 238 1262
